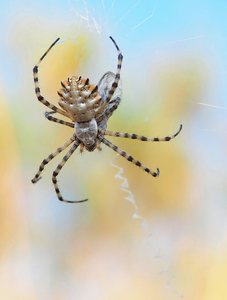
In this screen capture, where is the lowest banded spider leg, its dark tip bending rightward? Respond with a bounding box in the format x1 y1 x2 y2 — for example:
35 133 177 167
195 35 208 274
52 141 88 203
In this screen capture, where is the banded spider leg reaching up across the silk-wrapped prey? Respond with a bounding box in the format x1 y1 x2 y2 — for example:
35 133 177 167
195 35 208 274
97 36 123 114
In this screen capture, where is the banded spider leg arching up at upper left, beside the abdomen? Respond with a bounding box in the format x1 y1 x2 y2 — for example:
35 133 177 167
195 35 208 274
33 38 67 117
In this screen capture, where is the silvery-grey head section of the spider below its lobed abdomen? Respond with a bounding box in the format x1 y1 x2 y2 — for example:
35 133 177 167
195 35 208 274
74 118 98 151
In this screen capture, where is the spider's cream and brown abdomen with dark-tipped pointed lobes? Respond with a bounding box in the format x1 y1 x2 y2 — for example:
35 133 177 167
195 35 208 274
58 76 101 122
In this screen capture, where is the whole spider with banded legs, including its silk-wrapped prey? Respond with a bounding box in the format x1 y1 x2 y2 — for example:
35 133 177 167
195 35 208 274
32 36 182 203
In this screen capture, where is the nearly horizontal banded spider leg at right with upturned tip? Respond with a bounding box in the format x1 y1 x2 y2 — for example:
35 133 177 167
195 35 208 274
99 125 182 142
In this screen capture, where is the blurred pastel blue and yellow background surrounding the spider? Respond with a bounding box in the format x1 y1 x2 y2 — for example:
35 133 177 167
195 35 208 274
0 0 227 300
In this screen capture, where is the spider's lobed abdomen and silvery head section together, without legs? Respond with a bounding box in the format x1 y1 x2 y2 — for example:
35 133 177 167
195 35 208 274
58 76 102 151
